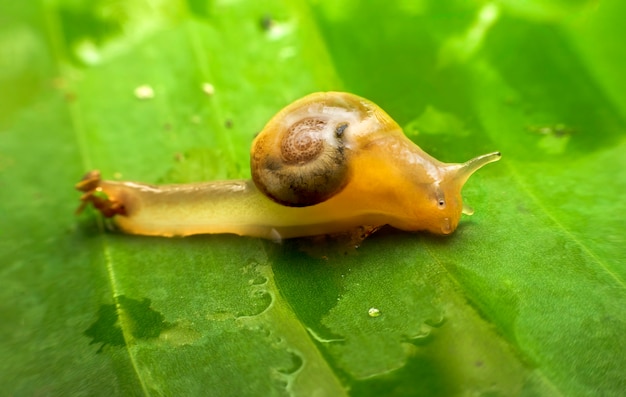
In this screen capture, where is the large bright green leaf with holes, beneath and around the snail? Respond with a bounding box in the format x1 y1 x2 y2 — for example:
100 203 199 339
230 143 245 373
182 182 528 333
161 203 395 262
0 0 626 396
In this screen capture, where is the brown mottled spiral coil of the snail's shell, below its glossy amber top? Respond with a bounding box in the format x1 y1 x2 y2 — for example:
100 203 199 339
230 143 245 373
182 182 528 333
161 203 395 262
251 112 349 207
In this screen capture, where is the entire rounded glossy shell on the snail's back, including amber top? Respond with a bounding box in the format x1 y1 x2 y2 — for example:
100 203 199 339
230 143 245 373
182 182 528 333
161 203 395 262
250 92 399 207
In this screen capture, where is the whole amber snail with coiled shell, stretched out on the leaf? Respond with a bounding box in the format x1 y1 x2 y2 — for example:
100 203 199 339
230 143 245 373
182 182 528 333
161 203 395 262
76 92 500 240
